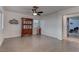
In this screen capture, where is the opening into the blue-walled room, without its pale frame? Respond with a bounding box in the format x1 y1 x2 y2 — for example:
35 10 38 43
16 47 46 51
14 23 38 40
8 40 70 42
67 16 79 39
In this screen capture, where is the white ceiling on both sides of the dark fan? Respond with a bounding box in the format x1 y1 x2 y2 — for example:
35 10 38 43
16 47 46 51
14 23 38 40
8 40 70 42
4 6 73 15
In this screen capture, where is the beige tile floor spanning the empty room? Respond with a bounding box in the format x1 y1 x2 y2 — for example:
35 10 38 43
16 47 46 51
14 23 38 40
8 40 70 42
0 36 79 52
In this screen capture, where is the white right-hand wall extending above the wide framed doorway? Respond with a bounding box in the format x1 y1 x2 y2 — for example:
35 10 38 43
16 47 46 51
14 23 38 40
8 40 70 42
41 7 79 40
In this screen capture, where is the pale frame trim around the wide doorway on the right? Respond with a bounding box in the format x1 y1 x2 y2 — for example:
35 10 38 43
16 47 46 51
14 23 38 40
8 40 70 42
62 13 79 39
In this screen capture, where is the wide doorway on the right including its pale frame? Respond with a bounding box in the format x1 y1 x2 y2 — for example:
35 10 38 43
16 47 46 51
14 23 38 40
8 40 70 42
63 14 79 42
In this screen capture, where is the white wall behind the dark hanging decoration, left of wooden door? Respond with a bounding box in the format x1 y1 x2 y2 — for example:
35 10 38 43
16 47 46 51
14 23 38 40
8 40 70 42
4 11 38 38
